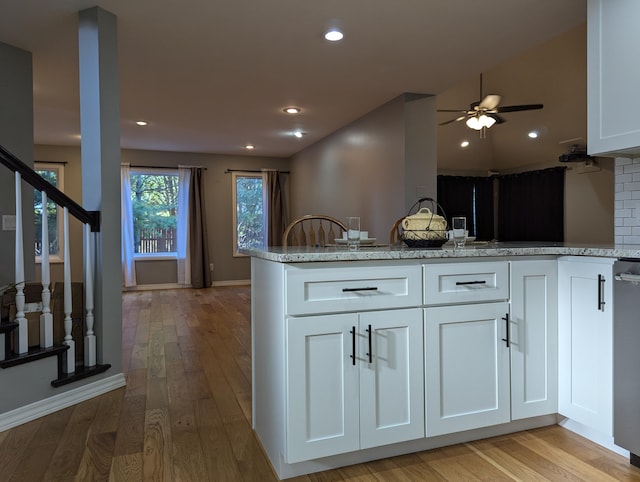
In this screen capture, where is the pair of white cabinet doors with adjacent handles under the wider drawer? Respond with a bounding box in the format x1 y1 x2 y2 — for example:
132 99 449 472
285 308 424 464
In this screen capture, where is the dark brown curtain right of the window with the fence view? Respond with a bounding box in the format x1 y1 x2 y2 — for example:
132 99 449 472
189 167 211 288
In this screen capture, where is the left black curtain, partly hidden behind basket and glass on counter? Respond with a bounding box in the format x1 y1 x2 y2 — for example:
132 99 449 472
438 175 494 240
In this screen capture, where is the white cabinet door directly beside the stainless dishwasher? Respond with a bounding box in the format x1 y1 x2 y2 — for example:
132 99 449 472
558 258 613 436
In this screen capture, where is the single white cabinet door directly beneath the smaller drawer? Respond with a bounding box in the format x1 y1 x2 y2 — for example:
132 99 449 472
425 303 510 437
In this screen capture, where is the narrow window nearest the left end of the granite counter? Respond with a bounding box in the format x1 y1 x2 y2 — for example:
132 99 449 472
232 172 264 256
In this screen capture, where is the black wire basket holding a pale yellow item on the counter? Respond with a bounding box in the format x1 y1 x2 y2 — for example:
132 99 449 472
400 198 447 248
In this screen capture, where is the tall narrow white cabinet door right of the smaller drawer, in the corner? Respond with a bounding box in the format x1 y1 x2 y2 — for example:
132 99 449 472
509 260 558 420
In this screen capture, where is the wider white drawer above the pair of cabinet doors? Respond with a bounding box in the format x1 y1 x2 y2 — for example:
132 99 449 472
285 264 422 315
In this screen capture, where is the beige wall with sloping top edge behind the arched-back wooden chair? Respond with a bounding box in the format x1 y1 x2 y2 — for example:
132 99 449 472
291 95 436 242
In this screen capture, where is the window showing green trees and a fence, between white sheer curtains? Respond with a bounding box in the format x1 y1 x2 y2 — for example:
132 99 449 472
130 169 178 257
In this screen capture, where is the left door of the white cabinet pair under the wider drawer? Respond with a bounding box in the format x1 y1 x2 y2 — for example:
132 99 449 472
285 314 360 464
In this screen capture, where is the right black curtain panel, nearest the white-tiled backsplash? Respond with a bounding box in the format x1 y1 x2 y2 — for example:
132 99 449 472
498 167 565 241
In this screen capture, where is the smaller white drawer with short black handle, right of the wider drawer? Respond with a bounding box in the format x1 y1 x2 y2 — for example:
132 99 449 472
424 261 509 305
